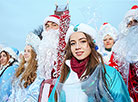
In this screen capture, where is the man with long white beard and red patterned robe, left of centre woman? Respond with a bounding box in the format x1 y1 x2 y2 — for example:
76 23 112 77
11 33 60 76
38 12 70 102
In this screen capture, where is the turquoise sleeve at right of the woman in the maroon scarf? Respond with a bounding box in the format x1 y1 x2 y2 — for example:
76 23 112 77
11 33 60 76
107 67 130 102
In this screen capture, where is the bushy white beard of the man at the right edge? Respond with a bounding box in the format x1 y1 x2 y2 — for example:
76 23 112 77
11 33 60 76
113 26 138 63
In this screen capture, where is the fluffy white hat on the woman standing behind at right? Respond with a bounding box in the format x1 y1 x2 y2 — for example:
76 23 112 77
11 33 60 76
99 23 118 41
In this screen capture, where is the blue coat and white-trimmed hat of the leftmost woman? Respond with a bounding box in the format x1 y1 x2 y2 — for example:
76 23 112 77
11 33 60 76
0 47 19 102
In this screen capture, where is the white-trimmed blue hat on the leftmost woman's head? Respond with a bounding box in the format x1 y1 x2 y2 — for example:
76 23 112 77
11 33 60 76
1 47 19 59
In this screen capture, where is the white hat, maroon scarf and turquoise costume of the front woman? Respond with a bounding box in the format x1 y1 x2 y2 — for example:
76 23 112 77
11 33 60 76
48 24 130 102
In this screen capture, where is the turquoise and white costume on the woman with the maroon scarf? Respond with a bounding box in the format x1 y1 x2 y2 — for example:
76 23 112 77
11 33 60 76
48 61 130 102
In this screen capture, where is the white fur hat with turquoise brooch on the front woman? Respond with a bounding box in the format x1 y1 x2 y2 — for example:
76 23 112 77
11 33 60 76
65 23 97 43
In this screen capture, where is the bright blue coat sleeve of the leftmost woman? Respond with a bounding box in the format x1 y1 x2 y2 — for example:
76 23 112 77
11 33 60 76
0 65 18 102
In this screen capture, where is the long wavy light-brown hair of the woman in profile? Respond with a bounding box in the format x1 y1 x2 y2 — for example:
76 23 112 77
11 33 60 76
15 45 37 88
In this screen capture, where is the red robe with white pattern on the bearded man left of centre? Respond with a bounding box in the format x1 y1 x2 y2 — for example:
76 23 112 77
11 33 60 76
38 10 70 102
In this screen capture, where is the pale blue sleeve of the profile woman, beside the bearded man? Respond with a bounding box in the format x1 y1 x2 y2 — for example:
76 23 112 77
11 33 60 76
23 77 44 102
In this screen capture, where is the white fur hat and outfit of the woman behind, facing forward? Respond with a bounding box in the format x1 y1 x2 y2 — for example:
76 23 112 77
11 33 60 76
98 23 118 69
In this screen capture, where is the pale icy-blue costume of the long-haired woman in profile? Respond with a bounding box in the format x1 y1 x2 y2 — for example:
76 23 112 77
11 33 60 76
8 72 43 102
